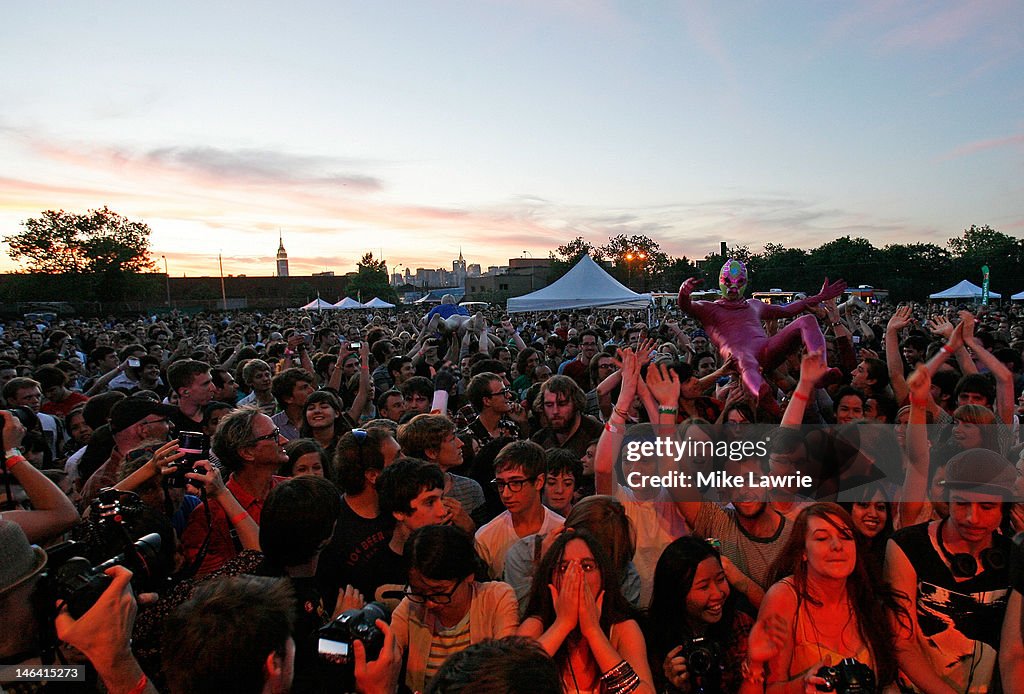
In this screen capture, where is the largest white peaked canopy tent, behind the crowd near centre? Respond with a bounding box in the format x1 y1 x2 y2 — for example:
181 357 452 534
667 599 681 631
508 256 652 313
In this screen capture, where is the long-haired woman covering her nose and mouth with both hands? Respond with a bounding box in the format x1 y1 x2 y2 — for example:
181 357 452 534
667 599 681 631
519 530 654 694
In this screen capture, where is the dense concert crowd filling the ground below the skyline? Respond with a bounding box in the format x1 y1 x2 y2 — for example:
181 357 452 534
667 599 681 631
0 280 1024 694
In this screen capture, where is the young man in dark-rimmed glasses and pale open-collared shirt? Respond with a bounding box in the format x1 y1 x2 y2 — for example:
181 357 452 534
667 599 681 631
476 441 565 578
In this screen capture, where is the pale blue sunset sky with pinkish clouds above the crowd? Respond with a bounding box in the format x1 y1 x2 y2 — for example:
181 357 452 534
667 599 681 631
0 0 1024 275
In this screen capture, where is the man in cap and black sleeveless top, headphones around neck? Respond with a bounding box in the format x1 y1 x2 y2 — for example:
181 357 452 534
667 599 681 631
885 448 1018 692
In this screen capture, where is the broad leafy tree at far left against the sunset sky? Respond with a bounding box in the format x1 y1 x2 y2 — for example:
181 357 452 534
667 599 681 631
4 207 155 274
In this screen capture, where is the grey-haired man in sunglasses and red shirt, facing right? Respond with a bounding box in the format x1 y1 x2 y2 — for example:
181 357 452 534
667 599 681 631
181 406 288 577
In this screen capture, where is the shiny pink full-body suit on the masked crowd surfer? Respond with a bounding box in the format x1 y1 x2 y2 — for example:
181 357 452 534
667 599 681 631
679 277 846 397
